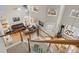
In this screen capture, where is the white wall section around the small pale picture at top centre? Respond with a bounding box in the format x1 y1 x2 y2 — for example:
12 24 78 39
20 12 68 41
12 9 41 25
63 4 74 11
30 5 47 21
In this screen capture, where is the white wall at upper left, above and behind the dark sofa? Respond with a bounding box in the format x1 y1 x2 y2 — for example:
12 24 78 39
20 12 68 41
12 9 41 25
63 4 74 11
0 5 27 25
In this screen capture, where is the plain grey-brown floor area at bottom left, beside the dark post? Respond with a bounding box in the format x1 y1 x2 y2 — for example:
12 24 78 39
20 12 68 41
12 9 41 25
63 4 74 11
7 43 28 53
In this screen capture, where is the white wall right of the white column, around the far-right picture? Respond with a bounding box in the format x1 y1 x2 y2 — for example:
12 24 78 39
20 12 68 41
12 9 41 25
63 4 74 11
62 5 79 28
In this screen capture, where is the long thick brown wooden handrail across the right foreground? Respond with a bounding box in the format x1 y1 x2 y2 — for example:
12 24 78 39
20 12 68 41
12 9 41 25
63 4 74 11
30 40 79 46
